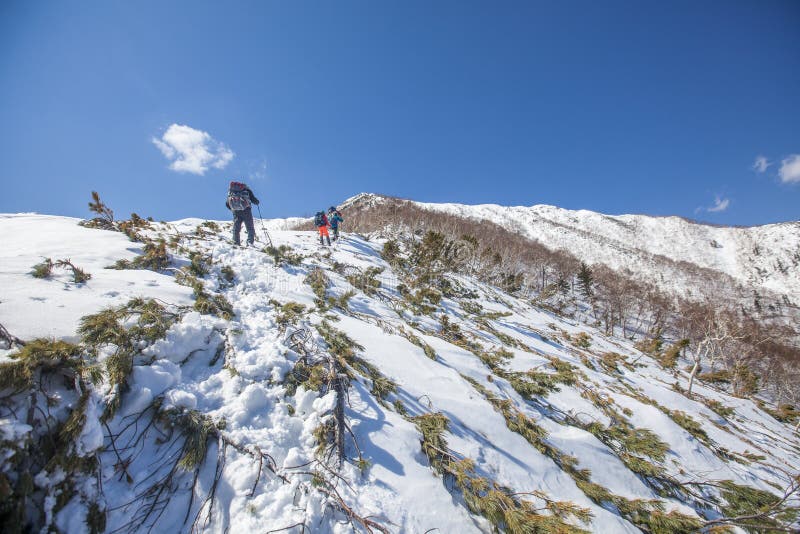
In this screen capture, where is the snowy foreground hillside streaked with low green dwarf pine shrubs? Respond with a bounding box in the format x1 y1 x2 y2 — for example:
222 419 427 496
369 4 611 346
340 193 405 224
0 214 800 534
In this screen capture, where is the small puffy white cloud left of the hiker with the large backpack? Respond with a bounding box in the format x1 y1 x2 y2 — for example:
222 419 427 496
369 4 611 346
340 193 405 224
152 124 235 175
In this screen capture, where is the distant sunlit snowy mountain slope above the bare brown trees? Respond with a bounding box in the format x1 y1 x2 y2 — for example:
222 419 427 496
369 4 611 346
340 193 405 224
368 195 800 305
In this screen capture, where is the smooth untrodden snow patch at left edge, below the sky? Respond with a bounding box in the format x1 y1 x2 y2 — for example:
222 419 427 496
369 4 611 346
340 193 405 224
0 214 192 339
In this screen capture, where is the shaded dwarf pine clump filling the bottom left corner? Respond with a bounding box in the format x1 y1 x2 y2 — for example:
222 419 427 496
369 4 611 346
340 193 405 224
0 339 103 532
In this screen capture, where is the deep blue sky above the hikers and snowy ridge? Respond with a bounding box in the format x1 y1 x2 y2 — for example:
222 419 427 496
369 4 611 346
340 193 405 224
0 0 800 225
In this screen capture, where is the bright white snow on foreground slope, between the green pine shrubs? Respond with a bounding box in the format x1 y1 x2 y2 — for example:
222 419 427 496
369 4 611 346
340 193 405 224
0 215 800 534
